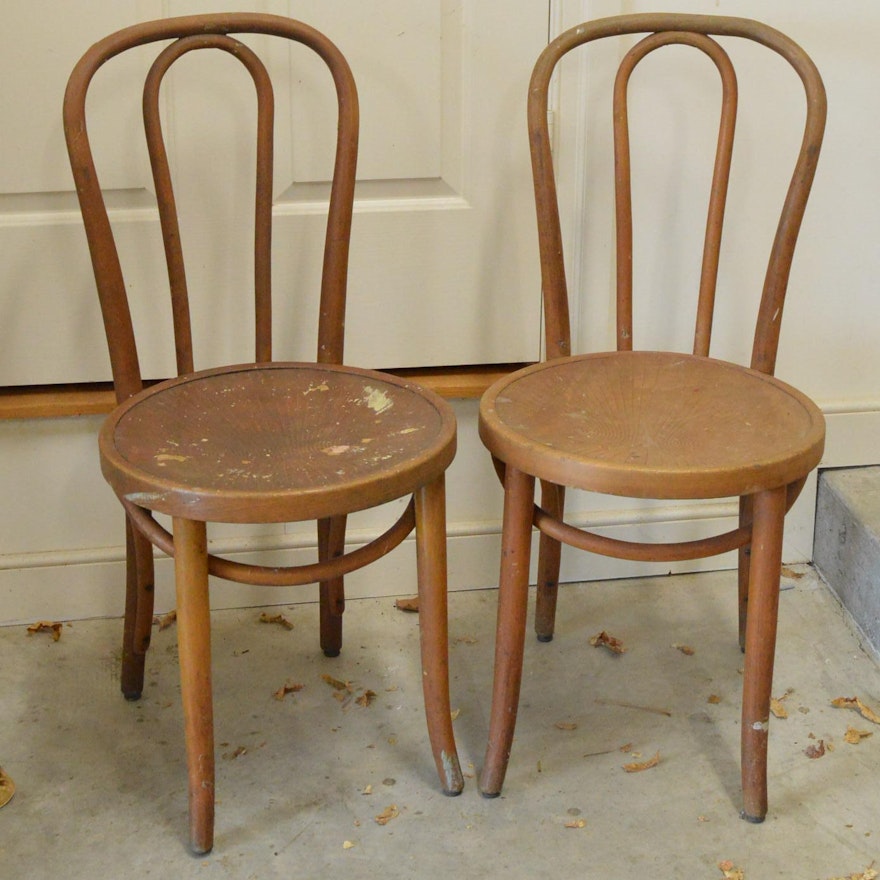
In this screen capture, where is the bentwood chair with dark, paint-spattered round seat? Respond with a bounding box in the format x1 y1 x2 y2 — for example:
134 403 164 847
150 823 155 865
64 14 463 852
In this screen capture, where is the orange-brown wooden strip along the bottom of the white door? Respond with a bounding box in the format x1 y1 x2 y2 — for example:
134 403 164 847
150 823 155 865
0 363 527 420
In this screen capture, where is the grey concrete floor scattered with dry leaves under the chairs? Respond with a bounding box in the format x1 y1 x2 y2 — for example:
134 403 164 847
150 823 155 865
0 567 880 880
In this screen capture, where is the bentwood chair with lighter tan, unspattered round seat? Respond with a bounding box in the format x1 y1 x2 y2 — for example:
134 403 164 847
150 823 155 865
479 14 825 822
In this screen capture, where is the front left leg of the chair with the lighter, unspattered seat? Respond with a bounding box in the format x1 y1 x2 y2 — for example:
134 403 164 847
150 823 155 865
480 464 535 797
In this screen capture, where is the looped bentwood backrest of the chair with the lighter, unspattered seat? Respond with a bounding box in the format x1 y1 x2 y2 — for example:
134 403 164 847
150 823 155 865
528 13 826 374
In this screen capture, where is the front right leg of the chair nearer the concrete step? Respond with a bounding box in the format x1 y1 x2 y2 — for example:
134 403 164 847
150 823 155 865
742 487 786 822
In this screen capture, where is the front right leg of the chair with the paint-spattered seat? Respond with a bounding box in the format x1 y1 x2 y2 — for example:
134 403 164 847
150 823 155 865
415 474 464 795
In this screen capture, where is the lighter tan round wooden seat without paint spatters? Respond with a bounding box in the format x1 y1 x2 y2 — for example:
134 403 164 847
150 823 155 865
480 351 825 498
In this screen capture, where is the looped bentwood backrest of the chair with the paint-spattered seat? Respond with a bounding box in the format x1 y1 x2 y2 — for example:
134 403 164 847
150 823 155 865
64 13 358 401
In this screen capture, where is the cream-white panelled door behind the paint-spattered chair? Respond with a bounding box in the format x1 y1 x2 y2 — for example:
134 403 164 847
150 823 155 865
0 0 549 386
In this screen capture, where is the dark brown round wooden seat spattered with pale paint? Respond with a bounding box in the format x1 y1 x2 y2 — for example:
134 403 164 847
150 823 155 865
100 363 455 522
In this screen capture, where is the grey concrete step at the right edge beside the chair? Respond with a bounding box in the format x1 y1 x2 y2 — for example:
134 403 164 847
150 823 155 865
813 467 880 655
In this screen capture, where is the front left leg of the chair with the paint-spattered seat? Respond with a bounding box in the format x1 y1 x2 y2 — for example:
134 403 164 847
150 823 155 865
174 517 214 853
